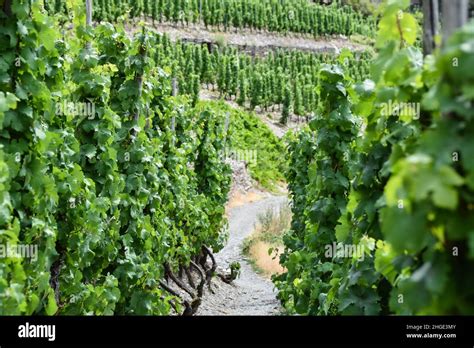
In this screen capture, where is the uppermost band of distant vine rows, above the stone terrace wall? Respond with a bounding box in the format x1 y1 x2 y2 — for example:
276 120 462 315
45 0 376 37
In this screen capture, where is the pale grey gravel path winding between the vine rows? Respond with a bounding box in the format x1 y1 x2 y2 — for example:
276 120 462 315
196 196 287 315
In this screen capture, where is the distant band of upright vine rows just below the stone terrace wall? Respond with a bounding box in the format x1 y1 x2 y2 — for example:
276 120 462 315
155 35 372 123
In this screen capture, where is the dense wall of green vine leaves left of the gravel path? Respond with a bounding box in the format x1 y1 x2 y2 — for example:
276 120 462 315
0 0 230 315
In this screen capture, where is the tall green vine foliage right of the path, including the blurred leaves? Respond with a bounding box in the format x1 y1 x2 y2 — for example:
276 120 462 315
274 1 474 314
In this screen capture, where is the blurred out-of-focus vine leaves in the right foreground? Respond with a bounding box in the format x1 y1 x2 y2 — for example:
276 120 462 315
381 23 474 314
